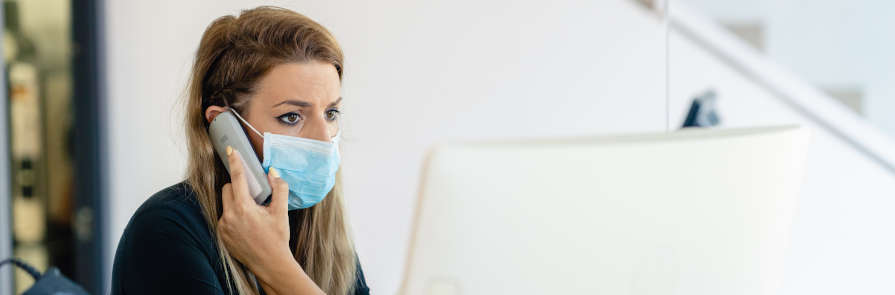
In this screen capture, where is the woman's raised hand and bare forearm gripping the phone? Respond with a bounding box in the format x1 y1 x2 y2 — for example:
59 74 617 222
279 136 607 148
217 146 322 294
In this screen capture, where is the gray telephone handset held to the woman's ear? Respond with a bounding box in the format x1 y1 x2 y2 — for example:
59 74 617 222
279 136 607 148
208 111 271 204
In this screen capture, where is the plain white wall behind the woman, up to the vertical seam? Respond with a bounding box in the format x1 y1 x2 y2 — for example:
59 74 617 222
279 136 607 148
106 0 666 294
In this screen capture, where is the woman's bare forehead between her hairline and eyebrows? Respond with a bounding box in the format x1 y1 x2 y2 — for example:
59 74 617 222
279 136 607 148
255 61 340 105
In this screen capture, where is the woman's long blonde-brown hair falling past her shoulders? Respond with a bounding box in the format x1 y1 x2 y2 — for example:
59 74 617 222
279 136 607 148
185 6 356 294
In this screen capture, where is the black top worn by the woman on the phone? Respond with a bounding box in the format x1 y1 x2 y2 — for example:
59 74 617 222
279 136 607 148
112 182 370 295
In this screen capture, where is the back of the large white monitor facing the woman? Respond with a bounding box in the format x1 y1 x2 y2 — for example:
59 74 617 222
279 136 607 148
401 127 807 295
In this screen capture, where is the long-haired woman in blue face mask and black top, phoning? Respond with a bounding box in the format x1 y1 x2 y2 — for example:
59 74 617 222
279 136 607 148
112 7 369 294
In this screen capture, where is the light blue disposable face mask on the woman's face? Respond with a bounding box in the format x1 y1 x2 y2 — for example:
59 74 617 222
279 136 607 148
231 109 341 210
